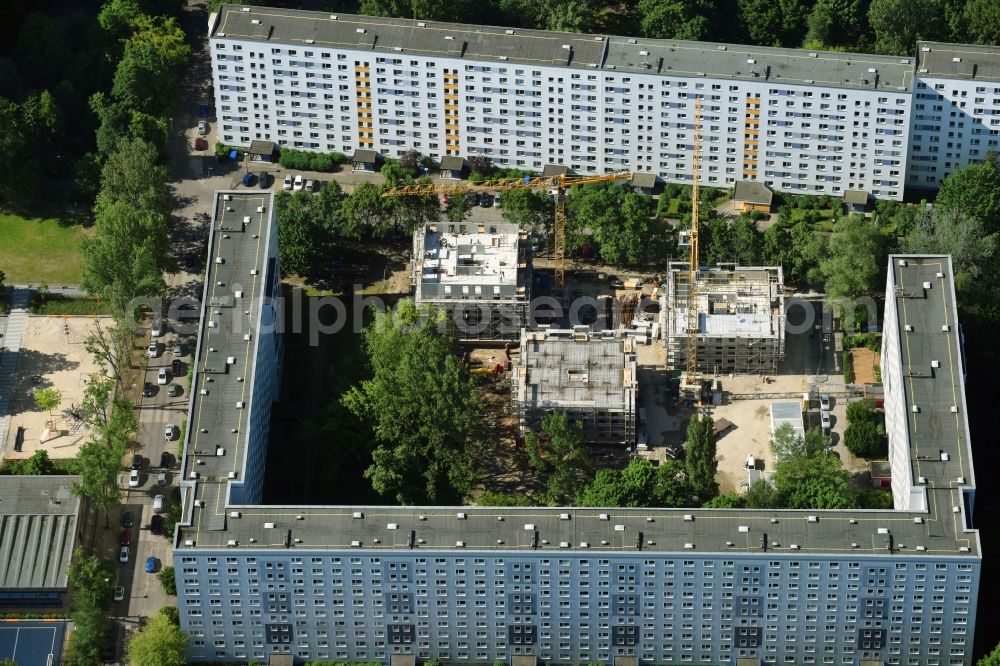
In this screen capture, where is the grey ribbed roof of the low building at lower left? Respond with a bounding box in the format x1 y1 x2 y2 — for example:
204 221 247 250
0 476 80 590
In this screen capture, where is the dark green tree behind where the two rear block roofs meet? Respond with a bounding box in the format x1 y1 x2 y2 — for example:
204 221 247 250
868 0 948 56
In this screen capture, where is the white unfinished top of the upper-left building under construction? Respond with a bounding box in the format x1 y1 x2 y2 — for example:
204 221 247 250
415 222 528 300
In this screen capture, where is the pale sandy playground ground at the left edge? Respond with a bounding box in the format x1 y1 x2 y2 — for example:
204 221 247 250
3 316 110 459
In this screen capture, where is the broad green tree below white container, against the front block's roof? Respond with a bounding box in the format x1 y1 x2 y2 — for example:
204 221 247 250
774 453 854 509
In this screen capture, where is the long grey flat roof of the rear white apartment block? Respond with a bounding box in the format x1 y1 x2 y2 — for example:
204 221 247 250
210 5 914 92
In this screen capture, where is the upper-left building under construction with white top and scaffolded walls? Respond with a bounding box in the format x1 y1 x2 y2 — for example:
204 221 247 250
412 222 532 341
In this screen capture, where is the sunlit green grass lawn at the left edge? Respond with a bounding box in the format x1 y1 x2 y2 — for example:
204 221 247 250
0 213 91 285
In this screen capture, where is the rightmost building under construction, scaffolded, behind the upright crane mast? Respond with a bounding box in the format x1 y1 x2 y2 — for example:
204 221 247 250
660 263 785 375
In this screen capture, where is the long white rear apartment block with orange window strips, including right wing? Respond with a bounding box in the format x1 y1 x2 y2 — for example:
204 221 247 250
210 5 1000 200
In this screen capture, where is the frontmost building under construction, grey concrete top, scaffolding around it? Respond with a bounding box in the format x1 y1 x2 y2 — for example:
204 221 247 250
511 327 639 445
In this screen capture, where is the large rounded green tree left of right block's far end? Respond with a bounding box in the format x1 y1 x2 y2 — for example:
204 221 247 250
820 215 887 299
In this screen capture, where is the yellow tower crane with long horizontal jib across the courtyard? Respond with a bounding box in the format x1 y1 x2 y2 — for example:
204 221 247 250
382 171 632 297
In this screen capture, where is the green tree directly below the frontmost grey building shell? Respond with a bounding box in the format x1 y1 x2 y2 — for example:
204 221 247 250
524 412 591 505
